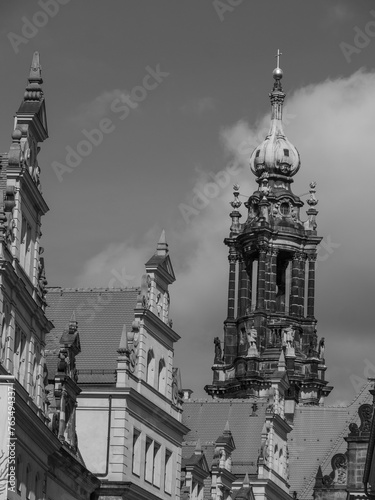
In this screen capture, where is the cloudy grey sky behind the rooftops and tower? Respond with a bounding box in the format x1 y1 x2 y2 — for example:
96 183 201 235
0 0 375 404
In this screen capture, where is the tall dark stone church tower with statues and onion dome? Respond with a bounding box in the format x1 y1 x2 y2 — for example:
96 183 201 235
205 52 332 406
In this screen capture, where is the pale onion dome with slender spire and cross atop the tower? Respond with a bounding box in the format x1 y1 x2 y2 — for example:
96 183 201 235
250 51 301 180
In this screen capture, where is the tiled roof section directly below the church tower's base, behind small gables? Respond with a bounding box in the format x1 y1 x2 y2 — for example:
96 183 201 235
182 399 267 475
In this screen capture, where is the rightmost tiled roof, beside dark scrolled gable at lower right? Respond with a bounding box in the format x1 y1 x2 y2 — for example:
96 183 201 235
288 384 372 500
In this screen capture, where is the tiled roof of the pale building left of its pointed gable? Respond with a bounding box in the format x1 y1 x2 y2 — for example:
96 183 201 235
46 288 139 383
